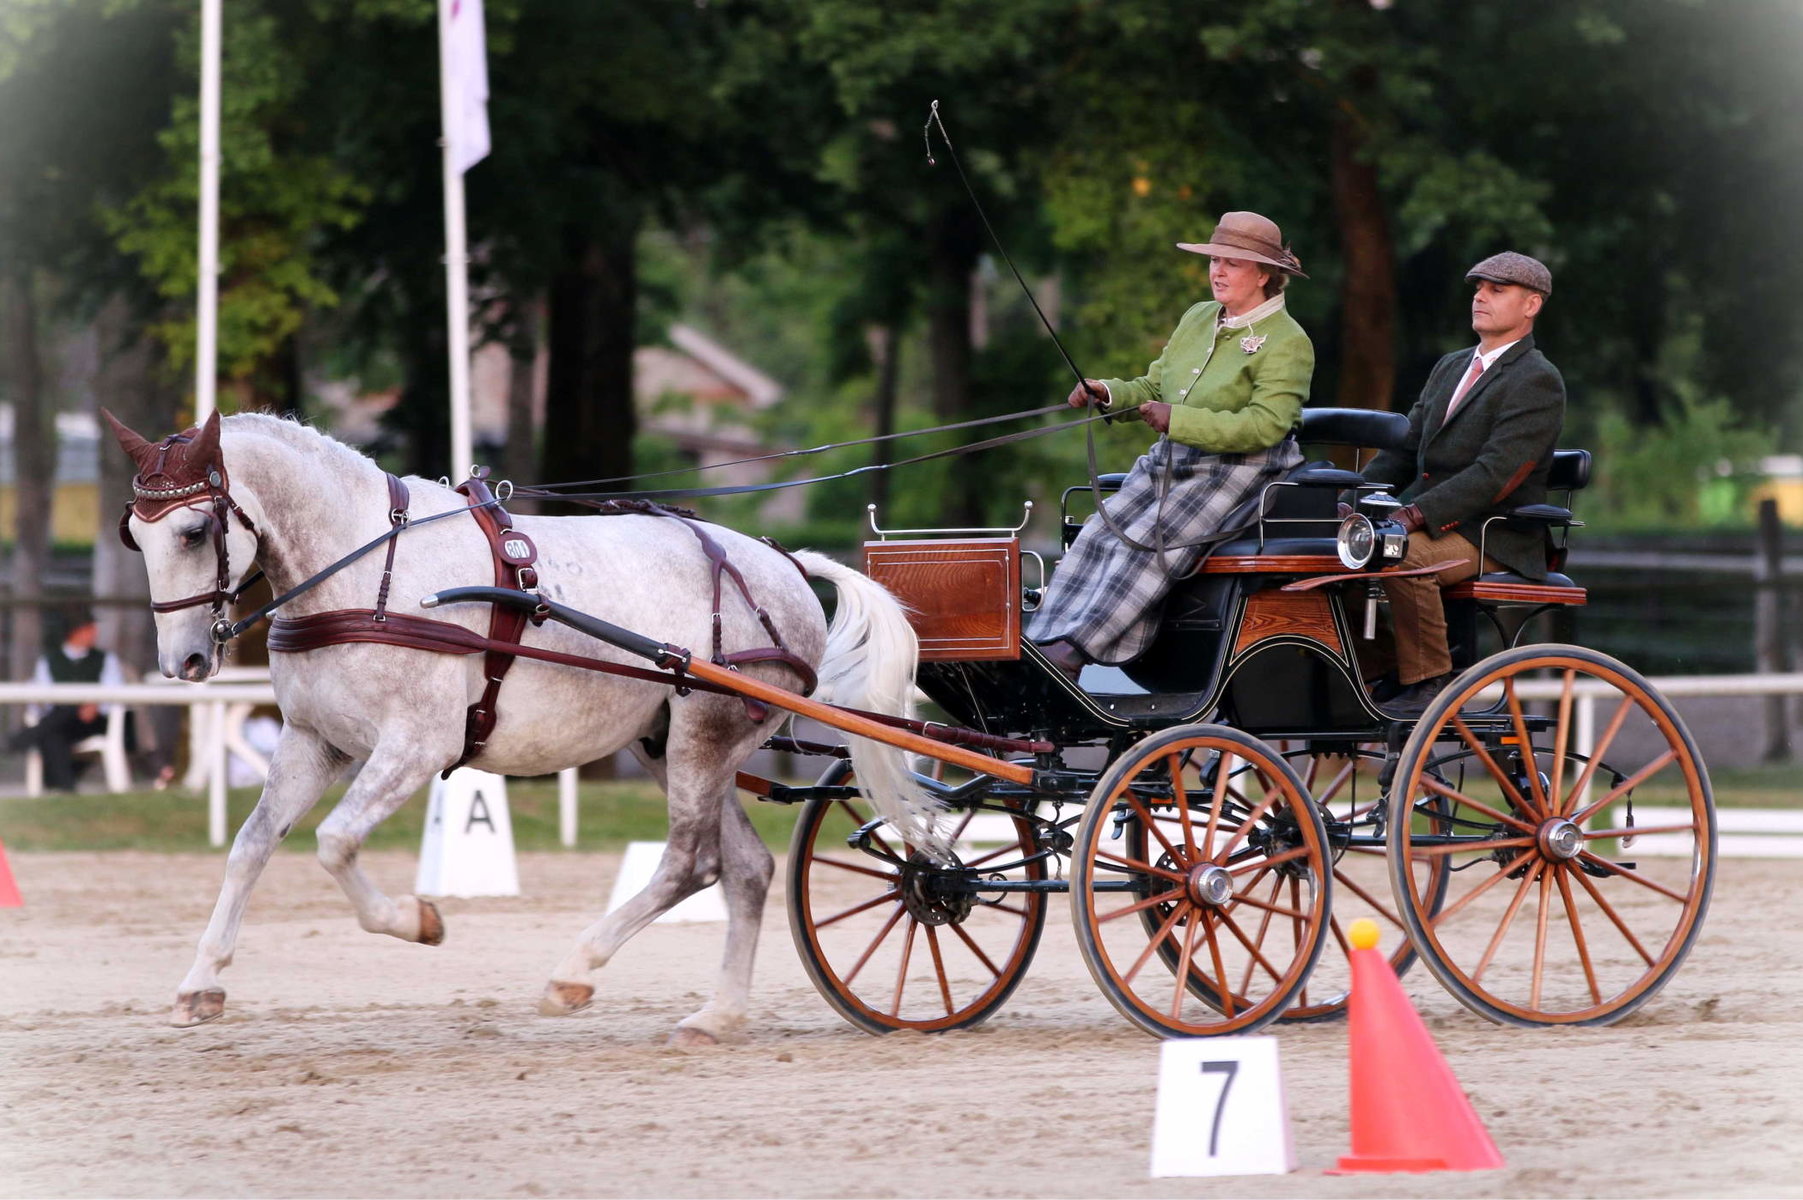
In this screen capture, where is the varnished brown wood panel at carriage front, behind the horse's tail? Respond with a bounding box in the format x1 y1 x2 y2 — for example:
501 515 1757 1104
864 537 1020 663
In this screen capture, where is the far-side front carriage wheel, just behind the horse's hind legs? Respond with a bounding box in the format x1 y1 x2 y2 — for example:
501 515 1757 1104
788 762 1046 1034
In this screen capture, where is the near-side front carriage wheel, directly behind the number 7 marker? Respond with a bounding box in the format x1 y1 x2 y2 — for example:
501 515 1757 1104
1071 724 1332 1036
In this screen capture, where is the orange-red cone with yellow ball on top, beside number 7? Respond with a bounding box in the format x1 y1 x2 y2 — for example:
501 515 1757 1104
1332 919 1504 1175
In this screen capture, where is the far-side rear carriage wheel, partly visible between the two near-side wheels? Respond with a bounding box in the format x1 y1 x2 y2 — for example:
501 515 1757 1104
1278 750 1450 1022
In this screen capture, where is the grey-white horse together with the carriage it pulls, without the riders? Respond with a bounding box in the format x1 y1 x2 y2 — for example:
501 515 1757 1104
119 409 1715 1040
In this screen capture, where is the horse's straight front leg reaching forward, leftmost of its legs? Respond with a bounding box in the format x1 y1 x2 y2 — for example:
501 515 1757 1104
169 724 346 1025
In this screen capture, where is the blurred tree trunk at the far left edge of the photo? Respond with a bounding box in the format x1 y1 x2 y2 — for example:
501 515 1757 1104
0 268 56 691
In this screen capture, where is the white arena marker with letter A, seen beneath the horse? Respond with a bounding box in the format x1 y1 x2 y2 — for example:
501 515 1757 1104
413 768 519 895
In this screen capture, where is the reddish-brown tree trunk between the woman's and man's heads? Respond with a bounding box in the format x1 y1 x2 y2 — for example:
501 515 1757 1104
1332 105 1396 409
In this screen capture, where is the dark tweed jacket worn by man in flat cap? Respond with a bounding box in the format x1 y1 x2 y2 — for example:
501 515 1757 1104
1365 337 1565 580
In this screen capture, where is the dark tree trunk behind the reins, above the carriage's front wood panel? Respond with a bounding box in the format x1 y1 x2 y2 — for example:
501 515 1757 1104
927 213 984 526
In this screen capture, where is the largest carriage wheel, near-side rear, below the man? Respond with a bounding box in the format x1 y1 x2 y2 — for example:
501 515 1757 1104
1388 645 1715 1025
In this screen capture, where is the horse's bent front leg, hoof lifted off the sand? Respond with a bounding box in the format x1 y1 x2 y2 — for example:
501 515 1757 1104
319 730 445 946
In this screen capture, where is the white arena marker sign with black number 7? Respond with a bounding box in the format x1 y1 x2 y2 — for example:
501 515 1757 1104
1152 1038 1296 1177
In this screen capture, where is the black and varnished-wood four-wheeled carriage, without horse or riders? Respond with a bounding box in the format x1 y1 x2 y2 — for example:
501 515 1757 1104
777 409 1715 1036
